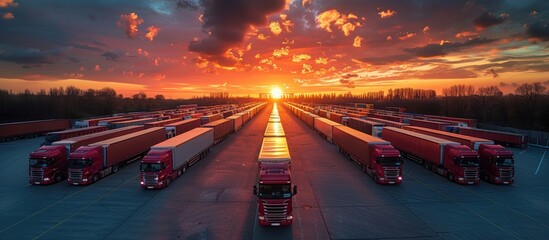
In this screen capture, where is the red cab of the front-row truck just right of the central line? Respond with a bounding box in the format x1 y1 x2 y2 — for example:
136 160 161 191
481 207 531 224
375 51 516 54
364 145 402 184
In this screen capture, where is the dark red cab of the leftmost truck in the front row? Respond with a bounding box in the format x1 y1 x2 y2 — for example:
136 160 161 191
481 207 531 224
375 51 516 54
29 146 67 185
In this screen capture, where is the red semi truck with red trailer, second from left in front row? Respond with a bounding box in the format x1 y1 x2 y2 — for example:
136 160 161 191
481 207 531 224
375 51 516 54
68 127 166 185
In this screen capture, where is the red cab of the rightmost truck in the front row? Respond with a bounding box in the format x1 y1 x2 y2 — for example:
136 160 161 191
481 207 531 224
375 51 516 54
478 144 515 184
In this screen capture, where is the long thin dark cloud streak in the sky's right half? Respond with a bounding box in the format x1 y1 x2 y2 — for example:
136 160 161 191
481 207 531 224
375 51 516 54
404 38 496 57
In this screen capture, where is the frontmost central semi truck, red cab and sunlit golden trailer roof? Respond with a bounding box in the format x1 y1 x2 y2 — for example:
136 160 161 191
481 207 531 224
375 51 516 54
253 137 297 226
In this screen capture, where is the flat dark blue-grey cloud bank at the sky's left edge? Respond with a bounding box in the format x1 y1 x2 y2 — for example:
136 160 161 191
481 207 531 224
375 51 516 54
0 47 67 66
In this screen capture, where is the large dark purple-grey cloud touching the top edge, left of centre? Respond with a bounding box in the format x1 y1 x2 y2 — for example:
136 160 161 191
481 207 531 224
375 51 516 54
189 0 285 65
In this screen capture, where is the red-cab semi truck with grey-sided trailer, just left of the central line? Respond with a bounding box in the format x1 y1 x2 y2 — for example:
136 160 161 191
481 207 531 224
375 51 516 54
141 127 214 189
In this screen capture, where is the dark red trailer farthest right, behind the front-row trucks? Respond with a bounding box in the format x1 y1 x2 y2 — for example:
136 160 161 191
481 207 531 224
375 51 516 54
459 127 528 148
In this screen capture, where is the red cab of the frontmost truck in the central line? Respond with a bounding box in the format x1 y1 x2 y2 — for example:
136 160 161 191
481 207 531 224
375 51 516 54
253 162 297 226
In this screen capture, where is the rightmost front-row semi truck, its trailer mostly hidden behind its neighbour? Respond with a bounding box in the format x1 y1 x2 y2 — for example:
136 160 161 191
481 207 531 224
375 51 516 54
404 126 515 184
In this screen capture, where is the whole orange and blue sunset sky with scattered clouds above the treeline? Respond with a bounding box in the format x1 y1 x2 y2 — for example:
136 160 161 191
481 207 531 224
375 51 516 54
0 0 549 98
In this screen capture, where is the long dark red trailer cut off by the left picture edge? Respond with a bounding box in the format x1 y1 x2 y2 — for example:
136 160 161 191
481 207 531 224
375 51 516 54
0 119 71 141
